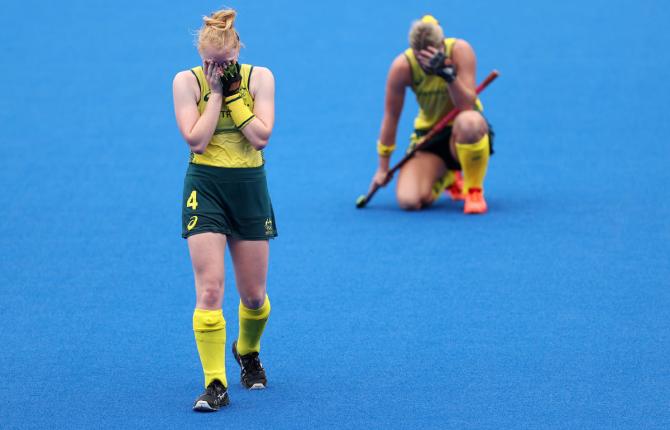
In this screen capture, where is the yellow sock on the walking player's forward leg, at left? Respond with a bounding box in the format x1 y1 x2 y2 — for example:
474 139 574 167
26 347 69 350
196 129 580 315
193 309 228 387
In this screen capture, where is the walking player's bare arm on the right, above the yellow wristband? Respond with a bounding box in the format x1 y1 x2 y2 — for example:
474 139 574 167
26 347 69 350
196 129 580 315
241 67 275 151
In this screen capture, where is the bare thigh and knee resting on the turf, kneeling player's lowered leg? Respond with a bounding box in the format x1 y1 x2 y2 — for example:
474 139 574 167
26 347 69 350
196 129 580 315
396 151 447 210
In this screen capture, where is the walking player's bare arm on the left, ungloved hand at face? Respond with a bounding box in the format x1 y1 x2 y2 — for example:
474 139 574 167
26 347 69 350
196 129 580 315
172 63 223 154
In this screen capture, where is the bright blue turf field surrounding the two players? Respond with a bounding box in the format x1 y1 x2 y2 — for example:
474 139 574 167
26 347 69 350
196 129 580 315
0 0 670 429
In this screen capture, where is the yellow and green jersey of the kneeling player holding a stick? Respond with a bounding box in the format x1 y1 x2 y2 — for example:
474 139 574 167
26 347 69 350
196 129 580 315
405 37 483 131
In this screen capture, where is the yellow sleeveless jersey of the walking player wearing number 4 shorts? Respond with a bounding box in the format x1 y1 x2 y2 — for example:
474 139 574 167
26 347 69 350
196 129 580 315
191 64 264 167
